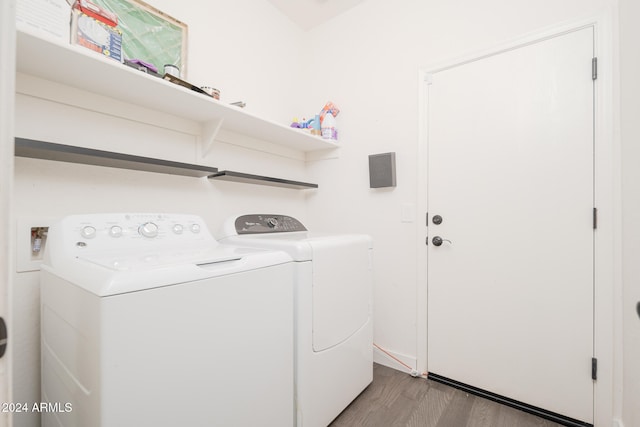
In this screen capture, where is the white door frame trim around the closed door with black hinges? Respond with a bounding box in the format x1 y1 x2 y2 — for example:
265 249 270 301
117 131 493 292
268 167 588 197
416 10 622 426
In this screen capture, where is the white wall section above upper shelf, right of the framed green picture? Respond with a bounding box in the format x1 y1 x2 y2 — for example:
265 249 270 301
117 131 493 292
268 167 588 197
128 0 305 123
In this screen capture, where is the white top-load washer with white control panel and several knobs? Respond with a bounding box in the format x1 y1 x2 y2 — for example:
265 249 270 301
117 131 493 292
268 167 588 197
41 214 295 427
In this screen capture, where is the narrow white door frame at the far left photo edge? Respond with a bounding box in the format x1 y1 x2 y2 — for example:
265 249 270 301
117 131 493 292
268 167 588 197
0 0 16 427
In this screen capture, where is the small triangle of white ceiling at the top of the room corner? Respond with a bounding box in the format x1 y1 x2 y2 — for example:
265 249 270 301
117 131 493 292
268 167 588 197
269 0 365 30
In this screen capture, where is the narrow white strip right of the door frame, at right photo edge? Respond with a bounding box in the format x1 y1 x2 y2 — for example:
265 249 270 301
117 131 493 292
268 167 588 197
620 0 640 426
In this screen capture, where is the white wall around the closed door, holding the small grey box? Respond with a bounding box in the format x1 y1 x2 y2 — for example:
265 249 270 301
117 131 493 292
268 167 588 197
307 0 640 426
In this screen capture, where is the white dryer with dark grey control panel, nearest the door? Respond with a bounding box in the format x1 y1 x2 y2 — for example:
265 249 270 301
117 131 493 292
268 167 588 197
217 215 373 427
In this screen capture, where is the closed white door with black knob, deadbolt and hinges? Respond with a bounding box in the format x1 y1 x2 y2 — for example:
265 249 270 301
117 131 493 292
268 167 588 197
427 27 594 423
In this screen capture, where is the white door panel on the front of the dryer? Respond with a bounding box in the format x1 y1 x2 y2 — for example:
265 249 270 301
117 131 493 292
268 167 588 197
309 235 372 352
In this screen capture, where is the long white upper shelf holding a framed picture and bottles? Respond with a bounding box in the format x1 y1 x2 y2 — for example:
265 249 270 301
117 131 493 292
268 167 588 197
17 29 338 152
